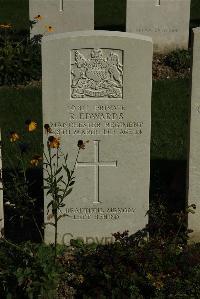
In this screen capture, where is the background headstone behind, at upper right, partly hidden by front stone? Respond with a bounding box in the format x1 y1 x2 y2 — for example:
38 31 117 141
126 0 191 52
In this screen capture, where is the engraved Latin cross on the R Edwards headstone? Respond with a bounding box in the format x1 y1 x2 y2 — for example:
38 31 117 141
76 140 117 203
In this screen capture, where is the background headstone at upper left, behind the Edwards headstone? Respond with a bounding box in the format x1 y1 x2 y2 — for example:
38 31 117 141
29 0 94 36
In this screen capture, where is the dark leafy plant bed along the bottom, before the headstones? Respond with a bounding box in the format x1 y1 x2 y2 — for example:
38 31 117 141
0 205 200 299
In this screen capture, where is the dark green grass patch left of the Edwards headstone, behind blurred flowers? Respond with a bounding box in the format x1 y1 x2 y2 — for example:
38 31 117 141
0 86 43 169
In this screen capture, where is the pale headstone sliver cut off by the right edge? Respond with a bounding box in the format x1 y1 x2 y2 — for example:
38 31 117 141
188 28 200 241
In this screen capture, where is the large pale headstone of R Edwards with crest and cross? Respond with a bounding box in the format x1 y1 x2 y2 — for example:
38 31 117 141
42 31 153 243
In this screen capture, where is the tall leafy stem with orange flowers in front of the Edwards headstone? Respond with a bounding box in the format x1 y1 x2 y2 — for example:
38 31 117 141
44 130 85 259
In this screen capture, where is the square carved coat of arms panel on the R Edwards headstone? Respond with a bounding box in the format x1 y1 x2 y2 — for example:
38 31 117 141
71 49 123 99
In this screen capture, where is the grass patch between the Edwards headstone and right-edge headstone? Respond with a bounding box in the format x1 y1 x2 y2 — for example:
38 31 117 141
151 79 190 160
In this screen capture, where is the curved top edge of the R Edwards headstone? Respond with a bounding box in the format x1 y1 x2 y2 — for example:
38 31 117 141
42 30 153 44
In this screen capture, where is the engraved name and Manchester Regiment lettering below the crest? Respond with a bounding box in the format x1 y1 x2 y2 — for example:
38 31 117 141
50 102 144 136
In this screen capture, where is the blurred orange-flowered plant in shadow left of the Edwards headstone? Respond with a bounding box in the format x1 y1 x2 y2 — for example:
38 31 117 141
2 120 43 241
